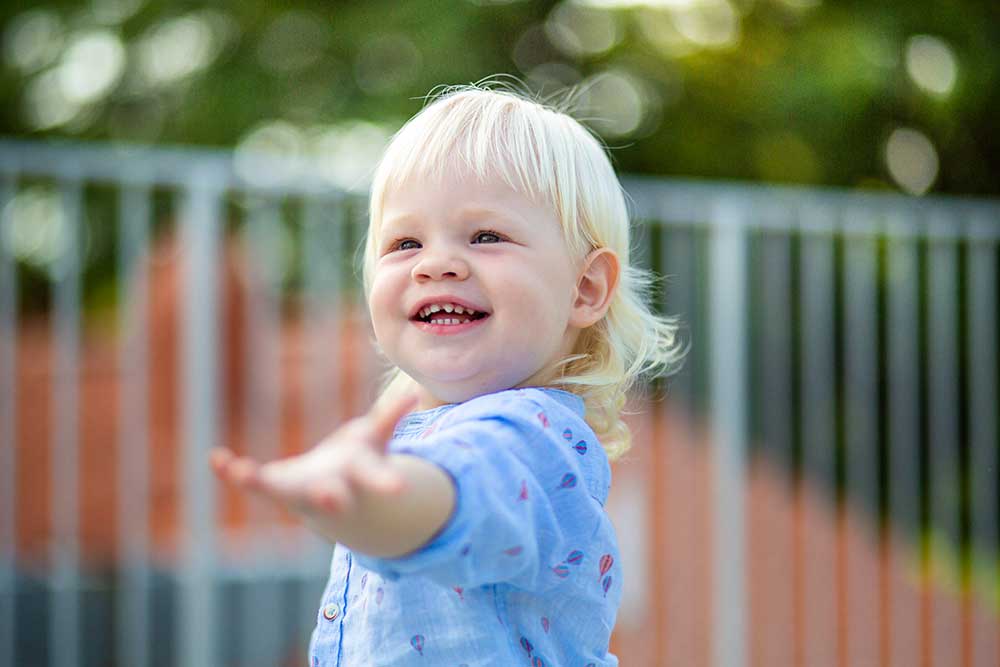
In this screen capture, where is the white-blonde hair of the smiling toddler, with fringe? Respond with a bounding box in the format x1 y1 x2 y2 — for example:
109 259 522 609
362 75 687 461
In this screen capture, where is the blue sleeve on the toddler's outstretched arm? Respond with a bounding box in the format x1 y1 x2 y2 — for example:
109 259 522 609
355 394 604 591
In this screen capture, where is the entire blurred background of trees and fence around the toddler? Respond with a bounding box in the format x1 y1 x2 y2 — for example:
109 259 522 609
0 0 1000 667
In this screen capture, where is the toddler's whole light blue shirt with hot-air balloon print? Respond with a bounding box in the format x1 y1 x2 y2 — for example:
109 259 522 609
309 388 622 667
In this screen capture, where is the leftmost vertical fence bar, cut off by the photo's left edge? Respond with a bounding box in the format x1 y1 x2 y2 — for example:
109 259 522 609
0 175 18 667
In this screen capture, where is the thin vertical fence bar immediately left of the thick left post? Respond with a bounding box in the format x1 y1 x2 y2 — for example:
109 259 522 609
115 184 151 667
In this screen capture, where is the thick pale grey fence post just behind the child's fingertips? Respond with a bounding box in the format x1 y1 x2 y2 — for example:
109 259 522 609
177 172 221 667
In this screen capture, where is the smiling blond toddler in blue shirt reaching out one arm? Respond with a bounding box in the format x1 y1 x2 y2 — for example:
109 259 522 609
212 75 683 667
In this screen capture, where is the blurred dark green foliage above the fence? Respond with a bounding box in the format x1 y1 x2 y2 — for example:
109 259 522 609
0 0 1000 194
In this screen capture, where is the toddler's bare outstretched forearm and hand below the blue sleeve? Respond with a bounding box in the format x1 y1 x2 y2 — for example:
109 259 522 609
211 395 455 558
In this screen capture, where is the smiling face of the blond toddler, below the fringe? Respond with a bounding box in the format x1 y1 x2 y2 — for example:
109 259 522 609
369 167 579 408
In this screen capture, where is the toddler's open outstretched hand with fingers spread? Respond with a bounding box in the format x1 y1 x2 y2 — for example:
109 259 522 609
211 394 417 538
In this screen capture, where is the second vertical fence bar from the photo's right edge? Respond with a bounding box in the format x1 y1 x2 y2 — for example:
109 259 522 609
927 213 962 666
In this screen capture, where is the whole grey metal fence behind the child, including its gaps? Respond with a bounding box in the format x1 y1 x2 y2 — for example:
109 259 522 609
0 140 1000 667
